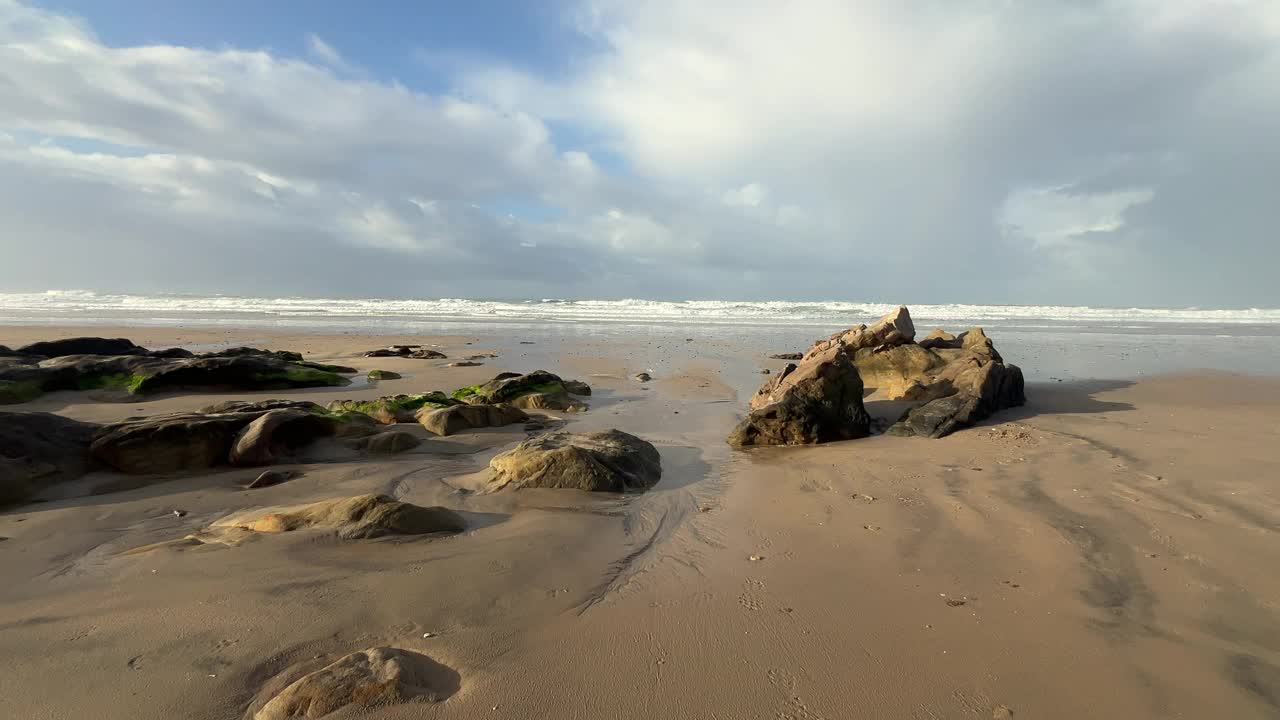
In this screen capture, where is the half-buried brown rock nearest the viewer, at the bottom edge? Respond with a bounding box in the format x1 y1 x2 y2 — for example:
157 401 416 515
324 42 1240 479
246 647 460 720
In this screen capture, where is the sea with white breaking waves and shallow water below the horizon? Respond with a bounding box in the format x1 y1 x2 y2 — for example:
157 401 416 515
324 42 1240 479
0 290 1280 382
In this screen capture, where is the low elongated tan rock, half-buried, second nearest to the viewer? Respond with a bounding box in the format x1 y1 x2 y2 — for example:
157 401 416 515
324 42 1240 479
212 495 467 539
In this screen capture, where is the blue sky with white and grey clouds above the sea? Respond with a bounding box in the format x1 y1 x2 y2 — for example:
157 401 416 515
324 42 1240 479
0 0 1280 307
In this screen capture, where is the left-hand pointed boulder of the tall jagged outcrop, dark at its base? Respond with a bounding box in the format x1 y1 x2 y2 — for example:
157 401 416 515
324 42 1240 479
728 343 870 447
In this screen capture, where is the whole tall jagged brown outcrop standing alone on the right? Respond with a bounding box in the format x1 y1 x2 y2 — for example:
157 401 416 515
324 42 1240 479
728 306 1025 446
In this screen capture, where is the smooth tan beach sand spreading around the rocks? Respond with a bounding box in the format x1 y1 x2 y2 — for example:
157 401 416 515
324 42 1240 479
0 328 1280 720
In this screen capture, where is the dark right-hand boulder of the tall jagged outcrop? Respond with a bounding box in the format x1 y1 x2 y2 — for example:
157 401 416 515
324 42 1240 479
888 348 1027 438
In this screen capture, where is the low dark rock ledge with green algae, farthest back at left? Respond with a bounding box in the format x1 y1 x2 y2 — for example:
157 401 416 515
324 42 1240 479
0 338 353 404
